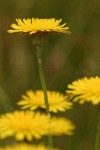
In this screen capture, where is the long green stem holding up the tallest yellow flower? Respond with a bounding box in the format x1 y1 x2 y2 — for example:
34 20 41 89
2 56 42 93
36 46 53 148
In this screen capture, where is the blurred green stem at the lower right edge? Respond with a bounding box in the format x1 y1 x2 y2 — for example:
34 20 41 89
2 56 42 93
95 116 100 150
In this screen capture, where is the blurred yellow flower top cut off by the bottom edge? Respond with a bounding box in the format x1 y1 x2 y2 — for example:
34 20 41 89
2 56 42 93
0 143 57 150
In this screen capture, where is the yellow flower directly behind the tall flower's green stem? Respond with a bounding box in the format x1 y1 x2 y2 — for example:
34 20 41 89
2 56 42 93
18 90 72 113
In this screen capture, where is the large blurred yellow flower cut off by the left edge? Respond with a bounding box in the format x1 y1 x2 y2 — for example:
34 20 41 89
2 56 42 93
0 111 50 141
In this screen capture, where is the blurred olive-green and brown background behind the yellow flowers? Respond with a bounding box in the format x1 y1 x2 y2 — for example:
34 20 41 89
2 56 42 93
0 0 100 150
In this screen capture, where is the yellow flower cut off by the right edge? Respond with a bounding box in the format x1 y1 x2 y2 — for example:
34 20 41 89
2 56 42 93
66 77 100 105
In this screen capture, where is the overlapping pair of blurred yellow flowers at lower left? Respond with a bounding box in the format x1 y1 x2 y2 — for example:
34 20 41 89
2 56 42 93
0 110 75 141
